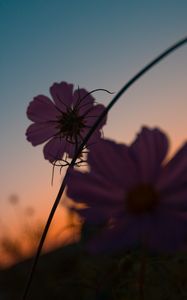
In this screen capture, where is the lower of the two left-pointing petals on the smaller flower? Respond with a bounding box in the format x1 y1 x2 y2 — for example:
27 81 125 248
26 123 57 146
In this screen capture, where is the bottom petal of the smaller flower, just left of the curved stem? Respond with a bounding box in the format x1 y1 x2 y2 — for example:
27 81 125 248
43 137 66 162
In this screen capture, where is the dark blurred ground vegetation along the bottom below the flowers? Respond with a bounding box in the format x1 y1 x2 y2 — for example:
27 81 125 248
0 243 187 300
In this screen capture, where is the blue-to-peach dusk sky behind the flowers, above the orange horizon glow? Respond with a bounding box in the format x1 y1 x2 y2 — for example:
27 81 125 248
0 0 187 234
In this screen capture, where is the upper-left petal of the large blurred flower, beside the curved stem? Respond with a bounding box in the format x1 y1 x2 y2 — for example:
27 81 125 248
88 139 138 191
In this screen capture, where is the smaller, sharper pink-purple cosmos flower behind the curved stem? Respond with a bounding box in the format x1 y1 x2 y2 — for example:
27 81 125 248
26 82 106 162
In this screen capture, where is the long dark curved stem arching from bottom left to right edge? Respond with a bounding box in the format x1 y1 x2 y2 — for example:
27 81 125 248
22 37 187 300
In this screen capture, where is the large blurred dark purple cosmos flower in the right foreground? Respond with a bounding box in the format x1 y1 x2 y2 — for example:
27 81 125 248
67 127 187 253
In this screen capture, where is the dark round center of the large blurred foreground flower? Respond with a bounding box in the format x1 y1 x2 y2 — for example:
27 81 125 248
125 184 159 215
